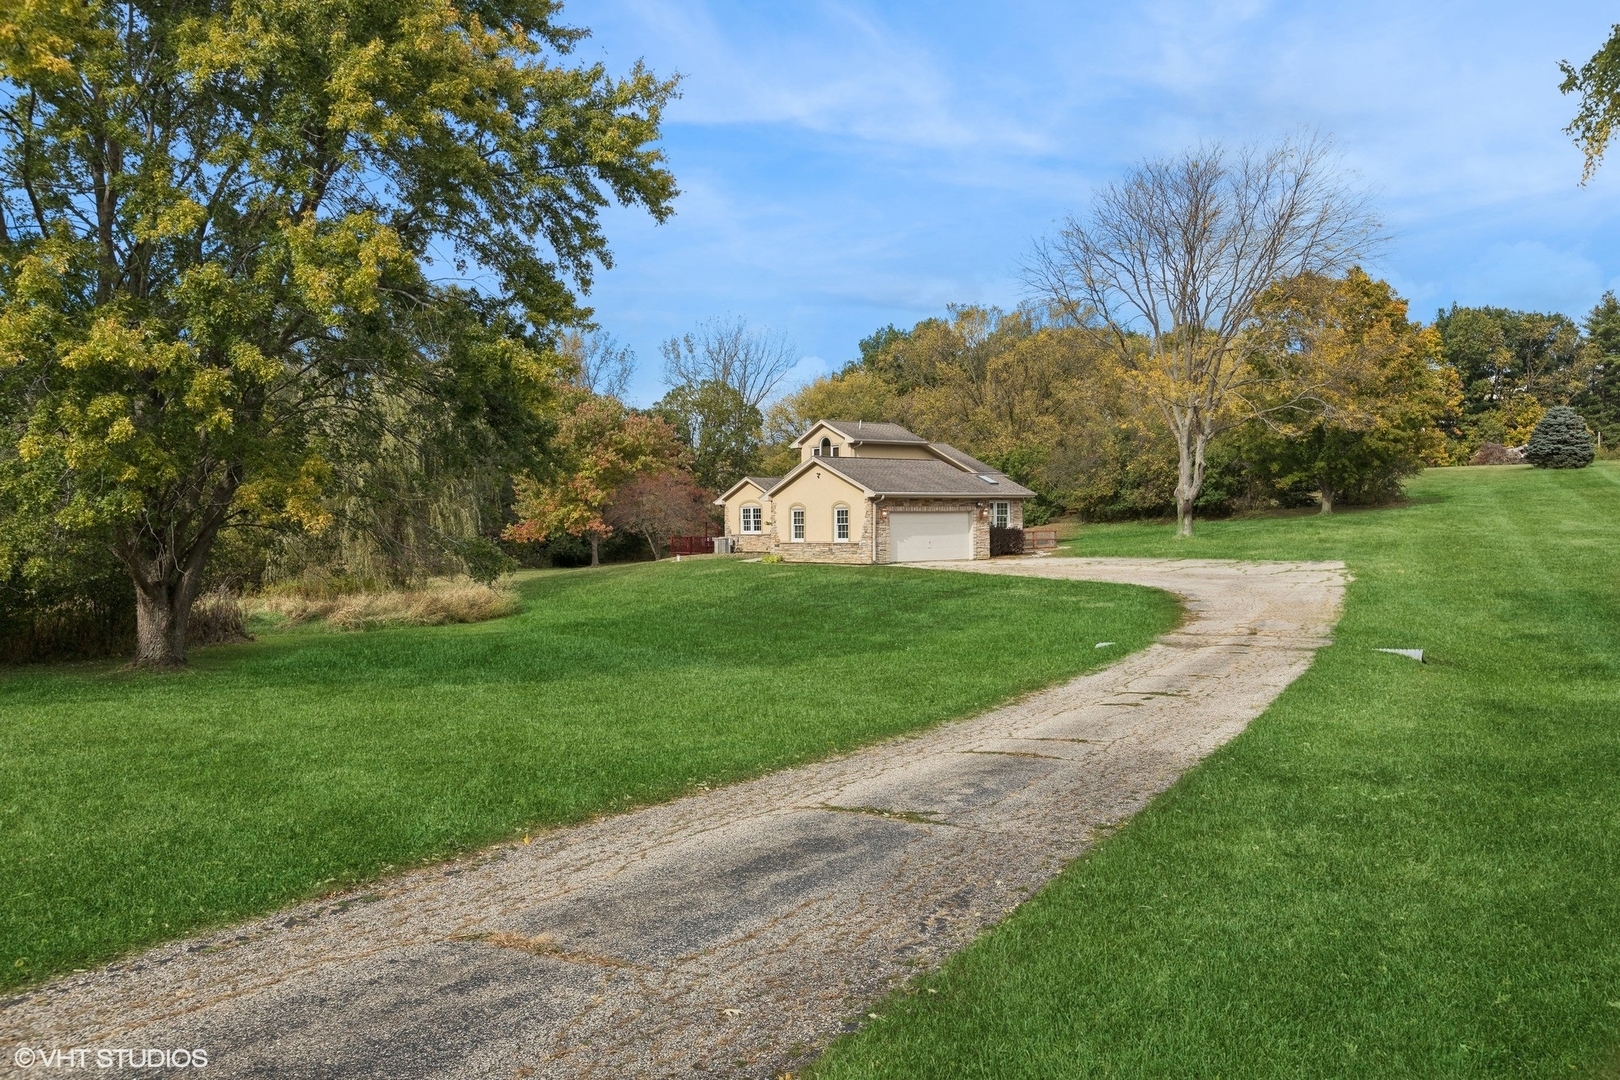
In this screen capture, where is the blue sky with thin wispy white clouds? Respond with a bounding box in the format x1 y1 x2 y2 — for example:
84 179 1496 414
564 0 1620 405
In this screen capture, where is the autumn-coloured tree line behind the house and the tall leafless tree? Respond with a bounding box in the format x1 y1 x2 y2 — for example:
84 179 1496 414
760 284 1620 523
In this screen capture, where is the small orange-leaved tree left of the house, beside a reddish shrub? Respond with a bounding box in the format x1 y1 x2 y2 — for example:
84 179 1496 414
505 392 687 567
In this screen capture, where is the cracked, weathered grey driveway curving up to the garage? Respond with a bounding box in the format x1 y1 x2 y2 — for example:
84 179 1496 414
0 559 1348 1078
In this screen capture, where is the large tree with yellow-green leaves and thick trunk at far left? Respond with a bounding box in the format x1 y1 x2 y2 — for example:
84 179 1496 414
0 0 676 664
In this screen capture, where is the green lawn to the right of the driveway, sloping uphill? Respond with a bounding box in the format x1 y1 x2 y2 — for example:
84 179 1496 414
815 463 1620 1080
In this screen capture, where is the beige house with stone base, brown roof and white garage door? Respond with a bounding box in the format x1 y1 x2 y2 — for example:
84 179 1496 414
714 419 1035 562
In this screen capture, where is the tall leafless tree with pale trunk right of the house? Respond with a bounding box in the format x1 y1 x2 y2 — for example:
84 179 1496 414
1025 138 1379 536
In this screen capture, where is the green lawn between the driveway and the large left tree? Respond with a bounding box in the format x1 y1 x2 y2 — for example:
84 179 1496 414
0 560 1178 986
